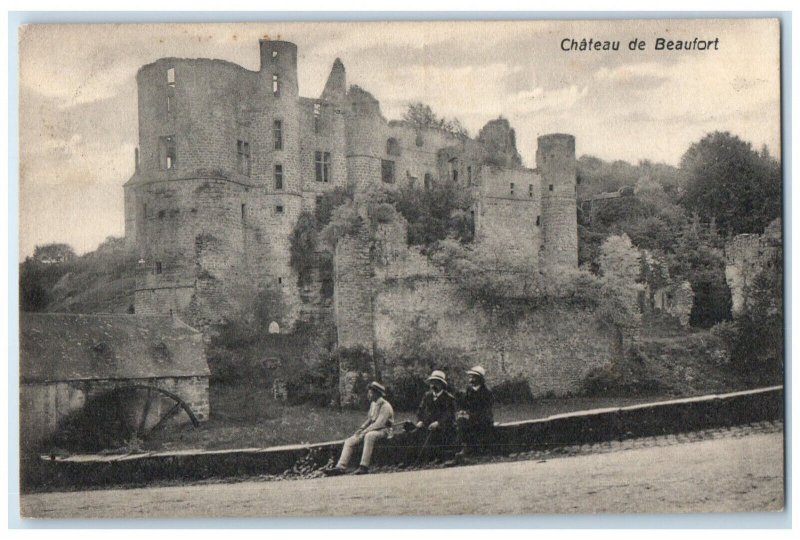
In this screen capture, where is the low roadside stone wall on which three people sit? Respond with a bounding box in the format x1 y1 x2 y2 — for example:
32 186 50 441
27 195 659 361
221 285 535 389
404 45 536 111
21 386 785 490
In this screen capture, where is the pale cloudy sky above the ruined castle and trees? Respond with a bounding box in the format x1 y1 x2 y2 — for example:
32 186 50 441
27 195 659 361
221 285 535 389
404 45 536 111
19 19 780 258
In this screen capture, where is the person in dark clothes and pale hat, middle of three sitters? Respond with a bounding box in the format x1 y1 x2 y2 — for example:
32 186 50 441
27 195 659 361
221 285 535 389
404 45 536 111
406 370 456 462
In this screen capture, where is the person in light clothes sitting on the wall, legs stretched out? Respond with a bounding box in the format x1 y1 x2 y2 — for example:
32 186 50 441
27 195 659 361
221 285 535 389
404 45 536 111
324 381 394 476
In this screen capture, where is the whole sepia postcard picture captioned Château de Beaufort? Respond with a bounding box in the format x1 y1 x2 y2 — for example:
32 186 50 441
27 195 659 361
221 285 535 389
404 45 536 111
15 18 787 523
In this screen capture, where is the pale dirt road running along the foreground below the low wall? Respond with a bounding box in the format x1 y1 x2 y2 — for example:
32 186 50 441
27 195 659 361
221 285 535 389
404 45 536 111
21 431 784 518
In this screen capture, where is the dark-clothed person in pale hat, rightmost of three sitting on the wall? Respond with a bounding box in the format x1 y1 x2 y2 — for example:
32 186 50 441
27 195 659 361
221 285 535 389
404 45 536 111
456 366 494 461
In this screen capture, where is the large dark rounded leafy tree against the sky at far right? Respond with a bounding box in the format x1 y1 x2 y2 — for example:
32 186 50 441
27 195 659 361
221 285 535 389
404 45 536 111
681 131 781 235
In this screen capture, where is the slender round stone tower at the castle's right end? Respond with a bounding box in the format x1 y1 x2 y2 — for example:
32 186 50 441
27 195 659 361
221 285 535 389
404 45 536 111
536 133 578 271
